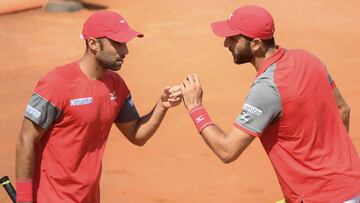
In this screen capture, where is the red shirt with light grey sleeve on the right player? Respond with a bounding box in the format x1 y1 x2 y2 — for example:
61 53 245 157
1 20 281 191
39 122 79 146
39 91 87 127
234 47 360 203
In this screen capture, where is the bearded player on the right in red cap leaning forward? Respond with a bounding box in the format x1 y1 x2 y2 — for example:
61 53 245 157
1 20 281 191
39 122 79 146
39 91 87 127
182 5 360 203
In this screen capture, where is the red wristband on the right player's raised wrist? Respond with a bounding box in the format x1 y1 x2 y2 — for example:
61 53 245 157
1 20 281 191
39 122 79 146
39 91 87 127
189 105 214 133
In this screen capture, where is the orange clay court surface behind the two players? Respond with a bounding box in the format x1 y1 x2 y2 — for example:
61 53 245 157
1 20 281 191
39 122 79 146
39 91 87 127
0 0 360 203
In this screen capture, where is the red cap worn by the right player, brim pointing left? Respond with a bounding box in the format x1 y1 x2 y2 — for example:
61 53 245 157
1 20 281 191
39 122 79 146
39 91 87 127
211 5 275 39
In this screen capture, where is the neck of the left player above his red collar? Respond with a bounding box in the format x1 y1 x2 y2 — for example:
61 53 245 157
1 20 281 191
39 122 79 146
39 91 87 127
79 53 105 80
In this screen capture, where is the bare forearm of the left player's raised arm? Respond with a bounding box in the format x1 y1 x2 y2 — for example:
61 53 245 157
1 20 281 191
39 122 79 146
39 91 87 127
134 101 168 145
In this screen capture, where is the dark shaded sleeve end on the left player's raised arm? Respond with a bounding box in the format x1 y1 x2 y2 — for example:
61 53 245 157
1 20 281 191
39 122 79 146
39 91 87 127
115 94 140 123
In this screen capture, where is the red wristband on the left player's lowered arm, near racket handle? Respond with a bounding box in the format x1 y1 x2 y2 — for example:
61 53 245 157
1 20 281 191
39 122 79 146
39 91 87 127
16 179 33 202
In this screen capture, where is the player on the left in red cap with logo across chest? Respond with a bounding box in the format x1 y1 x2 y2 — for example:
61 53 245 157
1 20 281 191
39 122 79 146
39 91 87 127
16 11 181 203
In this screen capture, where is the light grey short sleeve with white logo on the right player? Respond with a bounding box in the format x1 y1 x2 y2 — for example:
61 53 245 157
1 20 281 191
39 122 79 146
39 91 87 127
234 74 281 137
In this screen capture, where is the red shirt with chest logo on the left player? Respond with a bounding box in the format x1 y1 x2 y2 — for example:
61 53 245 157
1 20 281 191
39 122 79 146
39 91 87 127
25 62 139 203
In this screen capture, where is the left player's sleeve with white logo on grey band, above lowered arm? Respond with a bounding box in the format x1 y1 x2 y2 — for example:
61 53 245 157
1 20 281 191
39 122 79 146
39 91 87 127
24 74 65 129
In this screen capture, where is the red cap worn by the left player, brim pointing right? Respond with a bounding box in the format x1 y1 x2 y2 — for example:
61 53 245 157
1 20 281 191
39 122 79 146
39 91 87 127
82 10 144 43
